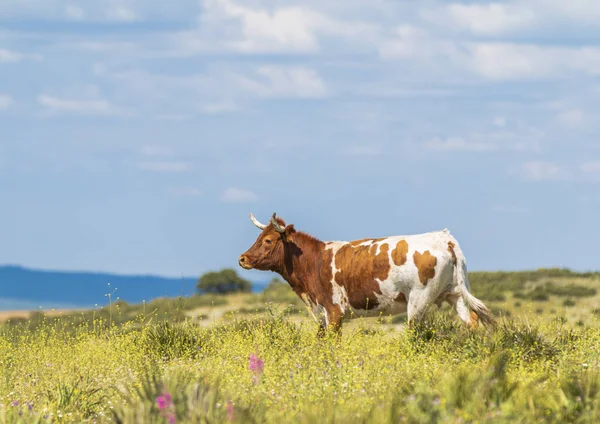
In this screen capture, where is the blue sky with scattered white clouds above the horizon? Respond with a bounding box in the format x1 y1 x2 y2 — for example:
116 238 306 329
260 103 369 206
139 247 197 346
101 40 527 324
0 0 600 279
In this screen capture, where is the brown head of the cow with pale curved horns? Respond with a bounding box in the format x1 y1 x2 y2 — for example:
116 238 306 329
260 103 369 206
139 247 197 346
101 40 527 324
238 214 296 271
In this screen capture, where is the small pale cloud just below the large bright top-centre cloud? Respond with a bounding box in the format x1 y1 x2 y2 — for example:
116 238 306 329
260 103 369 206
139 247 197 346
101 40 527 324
238 66 327 98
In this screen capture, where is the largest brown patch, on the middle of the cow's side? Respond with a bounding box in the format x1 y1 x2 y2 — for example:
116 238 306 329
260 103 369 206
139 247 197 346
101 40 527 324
335 243 390 310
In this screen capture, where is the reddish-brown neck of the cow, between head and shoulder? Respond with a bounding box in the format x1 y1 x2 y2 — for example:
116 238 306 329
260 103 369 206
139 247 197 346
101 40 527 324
276 232 325 294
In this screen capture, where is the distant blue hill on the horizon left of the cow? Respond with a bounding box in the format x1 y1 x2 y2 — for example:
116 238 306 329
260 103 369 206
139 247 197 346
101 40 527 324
0 265 267 310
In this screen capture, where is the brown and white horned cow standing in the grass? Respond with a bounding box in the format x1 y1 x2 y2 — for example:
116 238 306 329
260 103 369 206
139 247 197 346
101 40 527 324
239 214 494 334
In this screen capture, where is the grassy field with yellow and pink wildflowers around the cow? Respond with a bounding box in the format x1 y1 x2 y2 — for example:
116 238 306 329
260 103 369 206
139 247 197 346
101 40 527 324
0 269 600 423
